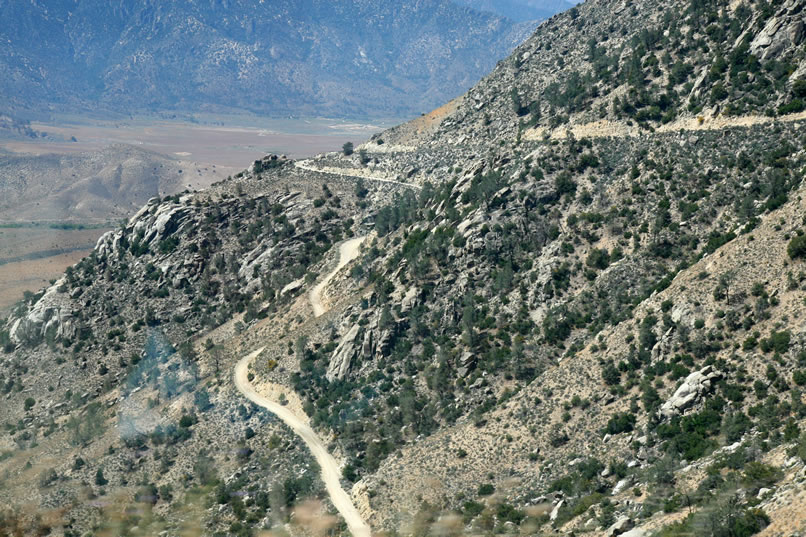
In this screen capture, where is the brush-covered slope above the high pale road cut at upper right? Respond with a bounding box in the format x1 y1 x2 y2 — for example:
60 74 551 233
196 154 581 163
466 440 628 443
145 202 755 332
387 0 806 143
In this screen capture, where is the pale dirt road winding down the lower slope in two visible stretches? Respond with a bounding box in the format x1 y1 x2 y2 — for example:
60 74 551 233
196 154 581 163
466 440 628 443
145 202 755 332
234 237 372 537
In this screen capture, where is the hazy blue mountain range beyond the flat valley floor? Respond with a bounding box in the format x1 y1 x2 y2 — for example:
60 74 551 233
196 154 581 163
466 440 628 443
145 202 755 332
0 0 570 117
